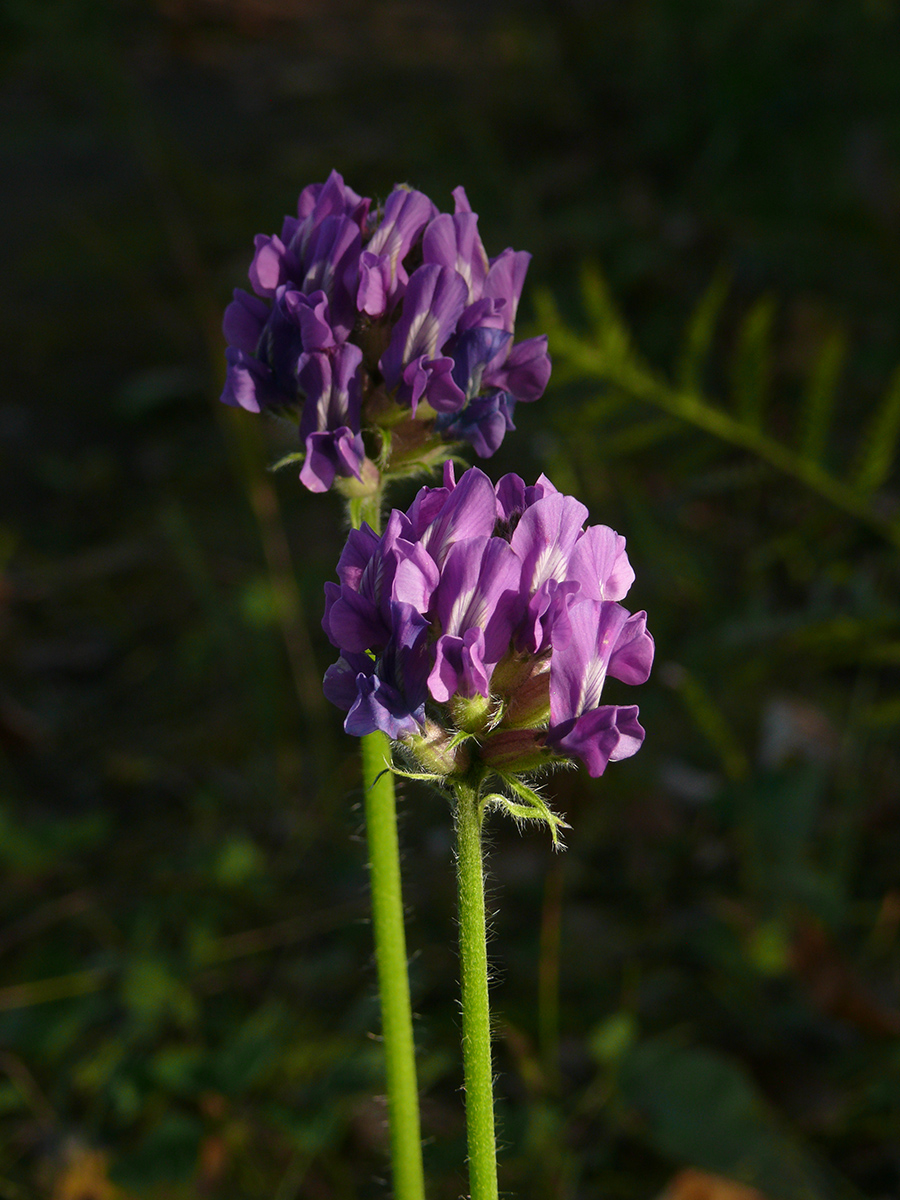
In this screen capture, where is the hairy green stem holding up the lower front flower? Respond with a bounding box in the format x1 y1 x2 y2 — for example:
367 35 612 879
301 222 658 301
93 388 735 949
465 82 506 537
456 784 497 1200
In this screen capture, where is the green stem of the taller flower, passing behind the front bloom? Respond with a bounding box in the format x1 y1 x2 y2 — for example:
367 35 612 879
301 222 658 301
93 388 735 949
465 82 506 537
350 494 425 1200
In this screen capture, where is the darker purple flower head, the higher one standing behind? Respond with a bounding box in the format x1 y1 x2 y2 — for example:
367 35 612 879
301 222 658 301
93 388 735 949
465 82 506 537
222 172 550 492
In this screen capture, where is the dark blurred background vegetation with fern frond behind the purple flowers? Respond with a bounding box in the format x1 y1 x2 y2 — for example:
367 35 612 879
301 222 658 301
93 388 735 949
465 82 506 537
0 0 900 1200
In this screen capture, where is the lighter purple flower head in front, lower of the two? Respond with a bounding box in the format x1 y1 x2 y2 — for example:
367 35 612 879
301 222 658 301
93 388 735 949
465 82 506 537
323 463 654 775
